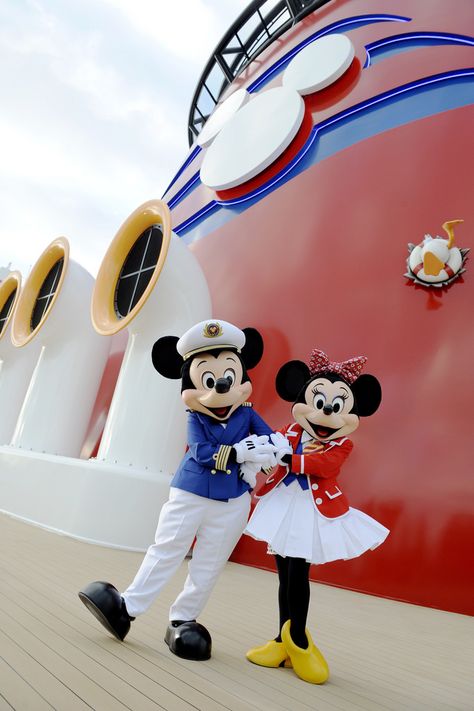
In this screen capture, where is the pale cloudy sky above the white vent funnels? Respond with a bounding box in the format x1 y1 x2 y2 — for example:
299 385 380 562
0 0 249 278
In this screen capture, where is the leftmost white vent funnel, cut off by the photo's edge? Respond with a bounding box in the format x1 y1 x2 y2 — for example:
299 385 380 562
0 272 38 444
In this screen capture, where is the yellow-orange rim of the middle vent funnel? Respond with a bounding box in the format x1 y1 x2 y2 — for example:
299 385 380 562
12 237 69 347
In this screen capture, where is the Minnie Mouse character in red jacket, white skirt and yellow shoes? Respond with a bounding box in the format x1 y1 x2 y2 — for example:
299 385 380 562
245 350 389 684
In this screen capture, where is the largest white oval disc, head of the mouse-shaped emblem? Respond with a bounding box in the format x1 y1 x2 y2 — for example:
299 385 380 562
201 86 304 190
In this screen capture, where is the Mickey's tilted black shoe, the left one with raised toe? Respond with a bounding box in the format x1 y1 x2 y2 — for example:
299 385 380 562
79 581 135 642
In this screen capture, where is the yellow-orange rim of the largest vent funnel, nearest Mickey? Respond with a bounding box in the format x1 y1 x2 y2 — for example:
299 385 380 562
91 200 171 336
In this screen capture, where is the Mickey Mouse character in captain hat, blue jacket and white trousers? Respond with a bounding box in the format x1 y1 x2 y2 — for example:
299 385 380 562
79 319 276 660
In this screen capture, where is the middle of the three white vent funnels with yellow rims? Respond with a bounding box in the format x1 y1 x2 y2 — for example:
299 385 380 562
12 237 109 456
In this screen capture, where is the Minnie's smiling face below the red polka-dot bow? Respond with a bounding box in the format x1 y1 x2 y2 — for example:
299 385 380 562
292 377 359 442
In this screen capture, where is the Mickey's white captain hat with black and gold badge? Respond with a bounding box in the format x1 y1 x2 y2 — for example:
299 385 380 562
176 318 245 360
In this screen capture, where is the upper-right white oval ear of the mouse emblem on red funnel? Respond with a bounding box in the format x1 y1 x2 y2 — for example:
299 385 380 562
282 35 355 96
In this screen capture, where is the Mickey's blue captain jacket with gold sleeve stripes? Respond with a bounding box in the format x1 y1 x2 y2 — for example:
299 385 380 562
171 403 273 501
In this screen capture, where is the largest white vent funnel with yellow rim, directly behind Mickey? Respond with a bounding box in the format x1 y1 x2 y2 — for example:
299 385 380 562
92 200 211 474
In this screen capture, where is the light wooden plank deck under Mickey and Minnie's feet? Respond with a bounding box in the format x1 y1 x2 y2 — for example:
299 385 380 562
0 515 474 711
